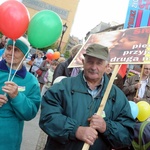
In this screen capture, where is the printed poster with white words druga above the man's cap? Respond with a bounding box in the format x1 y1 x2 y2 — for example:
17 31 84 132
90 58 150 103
68 27 150 68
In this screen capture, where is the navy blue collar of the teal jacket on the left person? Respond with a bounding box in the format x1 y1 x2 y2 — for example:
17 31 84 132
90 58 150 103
0 60 27 78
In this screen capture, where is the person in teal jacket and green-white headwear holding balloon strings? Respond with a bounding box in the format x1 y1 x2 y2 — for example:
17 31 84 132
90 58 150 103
0 37 41 150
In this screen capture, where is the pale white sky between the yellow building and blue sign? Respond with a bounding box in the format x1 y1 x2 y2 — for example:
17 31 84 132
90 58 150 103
70 0 129 39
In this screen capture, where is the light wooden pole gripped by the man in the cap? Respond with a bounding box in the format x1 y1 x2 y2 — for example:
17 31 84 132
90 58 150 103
82 65 121 150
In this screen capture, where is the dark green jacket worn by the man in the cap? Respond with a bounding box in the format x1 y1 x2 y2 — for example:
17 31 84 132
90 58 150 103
39 73 135 150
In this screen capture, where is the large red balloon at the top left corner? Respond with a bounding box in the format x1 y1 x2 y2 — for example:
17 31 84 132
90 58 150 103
0 1 30 40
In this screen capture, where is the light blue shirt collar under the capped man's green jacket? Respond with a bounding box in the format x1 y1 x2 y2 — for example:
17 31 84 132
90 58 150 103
83 74 104 97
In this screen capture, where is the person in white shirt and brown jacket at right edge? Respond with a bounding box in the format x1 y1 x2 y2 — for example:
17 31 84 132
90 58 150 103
122 64 150 103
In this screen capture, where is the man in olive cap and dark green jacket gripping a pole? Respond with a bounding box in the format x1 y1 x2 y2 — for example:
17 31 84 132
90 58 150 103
39 44 135 150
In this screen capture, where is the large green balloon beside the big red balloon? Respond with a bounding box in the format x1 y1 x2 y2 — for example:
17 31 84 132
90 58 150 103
27 10 63 48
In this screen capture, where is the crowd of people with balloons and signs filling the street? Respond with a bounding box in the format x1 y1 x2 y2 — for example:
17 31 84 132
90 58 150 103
0 34 150 150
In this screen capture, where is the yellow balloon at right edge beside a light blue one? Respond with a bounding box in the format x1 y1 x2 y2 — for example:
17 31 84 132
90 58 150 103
137 101 150 122
